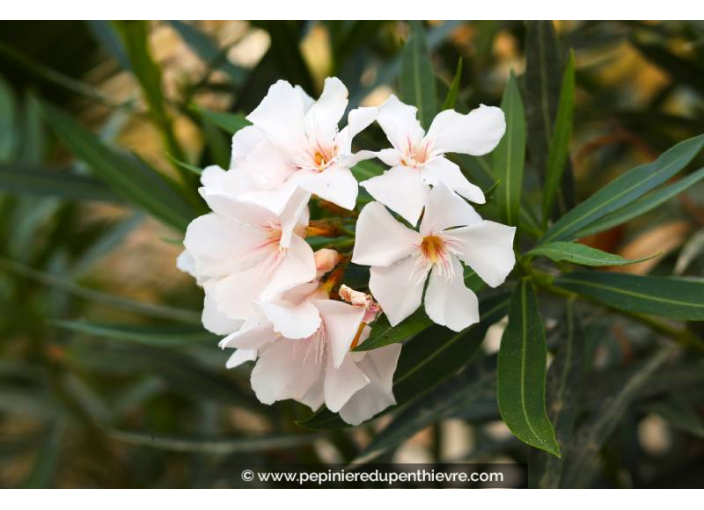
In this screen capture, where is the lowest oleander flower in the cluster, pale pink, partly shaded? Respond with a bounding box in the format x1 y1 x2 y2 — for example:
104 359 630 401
220 282 401 425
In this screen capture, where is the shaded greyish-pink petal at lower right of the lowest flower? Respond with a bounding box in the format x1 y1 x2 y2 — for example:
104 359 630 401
340 344 401 425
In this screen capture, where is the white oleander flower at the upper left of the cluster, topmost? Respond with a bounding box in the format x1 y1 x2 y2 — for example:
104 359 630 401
231 78 378 214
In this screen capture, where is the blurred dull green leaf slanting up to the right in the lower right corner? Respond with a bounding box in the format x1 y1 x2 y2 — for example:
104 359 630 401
562 346 677 488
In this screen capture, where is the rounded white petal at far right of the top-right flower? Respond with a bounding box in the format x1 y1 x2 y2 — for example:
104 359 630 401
426 105 506 156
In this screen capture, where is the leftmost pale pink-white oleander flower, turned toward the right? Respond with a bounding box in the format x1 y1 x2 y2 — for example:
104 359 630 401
181 179 316 328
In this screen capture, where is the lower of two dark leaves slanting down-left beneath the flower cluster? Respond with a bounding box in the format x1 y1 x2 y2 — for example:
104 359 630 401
352 356 496 464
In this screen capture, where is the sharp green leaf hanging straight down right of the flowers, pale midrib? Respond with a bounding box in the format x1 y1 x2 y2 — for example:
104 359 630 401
497 281 560 457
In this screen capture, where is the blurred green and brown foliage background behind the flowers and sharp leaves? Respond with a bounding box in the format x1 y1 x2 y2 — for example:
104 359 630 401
0 21 704 487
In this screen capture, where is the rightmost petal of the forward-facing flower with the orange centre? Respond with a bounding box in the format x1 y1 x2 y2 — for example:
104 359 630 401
451 221 516 287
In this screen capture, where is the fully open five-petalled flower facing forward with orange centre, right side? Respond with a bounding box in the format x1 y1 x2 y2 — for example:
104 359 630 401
352 182 516 331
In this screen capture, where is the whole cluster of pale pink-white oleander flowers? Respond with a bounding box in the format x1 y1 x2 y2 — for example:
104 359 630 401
178 78 515 425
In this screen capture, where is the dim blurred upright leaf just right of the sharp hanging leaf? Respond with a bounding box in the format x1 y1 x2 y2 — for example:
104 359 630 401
528 300 586 489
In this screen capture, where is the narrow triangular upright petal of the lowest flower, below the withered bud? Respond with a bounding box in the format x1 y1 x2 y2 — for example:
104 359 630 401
315 299 365 367
